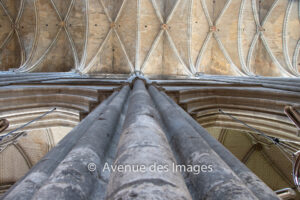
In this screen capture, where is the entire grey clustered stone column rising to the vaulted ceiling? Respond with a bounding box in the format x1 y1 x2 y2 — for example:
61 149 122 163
4 79 278 200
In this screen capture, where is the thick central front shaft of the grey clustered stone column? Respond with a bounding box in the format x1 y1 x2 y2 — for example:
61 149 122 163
107 79 191 200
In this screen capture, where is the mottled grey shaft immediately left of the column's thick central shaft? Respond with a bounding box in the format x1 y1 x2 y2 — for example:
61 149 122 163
29 85 130 200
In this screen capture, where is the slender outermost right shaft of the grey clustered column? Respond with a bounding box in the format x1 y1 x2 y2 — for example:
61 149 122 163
162 93 279 200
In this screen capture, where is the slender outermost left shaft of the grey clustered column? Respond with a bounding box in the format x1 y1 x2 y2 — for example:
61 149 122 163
3 86 128 200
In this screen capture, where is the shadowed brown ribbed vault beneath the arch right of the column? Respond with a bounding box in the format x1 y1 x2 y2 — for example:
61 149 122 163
207 128 295 190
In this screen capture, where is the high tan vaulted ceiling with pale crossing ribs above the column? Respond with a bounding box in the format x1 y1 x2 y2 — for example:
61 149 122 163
0 0 300 77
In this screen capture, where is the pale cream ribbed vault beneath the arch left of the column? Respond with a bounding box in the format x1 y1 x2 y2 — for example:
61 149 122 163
0 126 72 196
